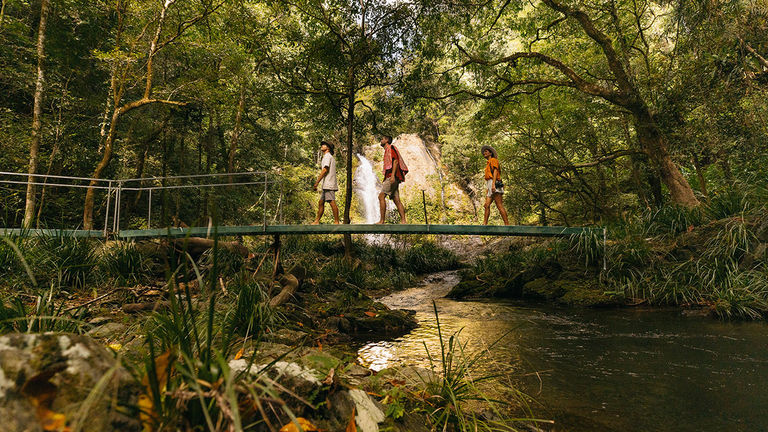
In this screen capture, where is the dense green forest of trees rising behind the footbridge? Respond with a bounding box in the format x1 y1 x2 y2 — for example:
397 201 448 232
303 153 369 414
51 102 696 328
0 0 768 227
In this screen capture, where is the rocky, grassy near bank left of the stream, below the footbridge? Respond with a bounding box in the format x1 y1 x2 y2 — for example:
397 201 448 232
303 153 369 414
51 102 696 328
0 238 540 431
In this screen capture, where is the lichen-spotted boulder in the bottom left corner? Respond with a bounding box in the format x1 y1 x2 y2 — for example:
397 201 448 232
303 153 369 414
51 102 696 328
0 333 141 432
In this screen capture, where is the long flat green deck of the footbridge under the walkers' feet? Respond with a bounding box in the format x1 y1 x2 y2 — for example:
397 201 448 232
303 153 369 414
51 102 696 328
0 224 601 239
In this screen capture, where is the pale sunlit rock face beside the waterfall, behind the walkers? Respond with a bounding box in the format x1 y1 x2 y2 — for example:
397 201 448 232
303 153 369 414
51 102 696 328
364 134 474 223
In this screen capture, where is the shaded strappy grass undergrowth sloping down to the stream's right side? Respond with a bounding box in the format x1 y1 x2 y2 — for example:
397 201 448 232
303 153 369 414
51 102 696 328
473 181 768 319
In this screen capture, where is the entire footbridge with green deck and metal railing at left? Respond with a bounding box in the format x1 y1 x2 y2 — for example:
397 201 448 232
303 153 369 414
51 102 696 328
0 171 605 240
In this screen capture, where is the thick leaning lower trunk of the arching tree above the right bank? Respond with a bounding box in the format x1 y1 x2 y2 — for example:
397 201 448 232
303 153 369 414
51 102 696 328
632 107 700 207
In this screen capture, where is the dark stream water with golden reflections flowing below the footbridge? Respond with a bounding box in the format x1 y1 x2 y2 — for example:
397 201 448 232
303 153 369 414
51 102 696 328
358 272 768 432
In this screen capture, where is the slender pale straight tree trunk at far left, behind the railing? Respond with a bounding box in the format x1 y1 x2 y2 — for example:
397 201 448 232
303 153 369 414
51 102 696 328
23 0 48 228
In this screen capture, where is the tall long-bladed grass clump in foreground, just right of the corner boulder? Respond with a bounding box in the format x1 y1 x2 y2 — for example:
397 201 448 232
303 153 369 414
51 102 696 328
136 248 294 431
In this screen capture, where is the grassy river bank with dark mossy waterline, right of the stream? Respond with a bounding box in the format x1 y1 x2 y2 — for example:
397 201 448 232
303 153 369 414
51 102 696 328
448 209 768 320
